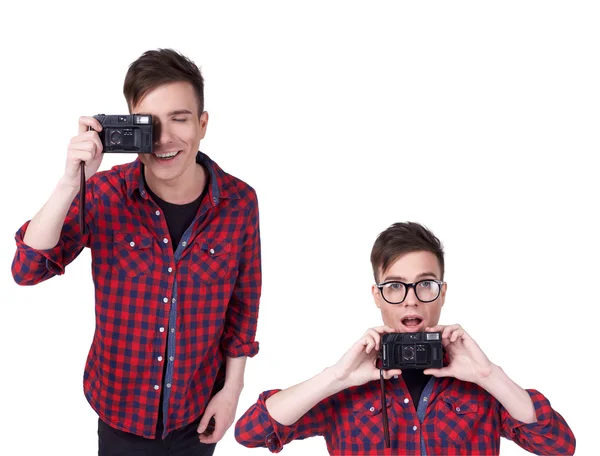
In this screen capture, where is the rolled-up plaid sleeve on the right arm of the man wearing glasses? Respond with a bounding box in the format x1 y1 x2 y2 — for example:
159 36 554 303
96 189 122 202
500 389 575 455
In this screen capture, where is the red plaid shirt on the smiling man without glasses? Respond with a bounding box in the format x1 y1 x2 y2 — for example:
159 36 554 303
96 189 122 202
12 152 261 438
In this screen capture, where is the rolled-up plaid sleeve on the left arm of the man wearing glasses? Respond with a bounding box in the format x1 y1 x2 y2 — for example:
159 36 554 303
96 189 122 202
235 390 332 453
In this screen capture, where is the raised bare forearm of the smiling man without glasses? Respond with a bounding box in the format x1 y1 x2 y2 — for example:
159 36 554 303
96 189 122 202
23 181 78 250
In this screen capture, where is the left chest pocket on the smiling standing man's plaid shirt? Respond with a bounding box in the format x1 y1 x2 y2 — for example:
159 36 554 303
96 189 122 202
113 231 153 277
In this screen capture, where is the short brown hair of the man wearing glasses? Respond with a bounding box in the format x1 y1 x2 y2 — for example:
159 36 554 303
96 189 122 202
371 222 444 282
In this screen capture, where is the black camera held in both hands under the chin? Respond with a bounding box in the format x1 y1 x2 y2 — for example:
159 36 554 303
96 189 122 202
380 332 444 370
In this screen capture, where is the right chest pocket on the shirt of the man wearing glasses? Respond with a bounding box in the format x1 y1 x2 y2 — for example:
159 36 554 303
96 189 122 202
435 396 479 445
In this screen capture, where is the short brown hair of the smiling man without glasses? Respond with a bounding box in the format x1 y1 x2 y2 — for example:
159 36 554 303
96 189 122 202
123 49 204 116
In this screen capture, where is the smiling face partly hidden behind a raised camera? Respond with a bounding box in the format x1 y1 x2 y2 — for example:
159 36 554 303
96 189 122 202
133 82 208 183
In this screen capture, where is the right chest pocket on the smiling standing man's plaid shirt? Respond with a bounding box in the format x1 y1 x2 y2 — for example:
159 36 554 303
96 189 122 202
190 239 231 283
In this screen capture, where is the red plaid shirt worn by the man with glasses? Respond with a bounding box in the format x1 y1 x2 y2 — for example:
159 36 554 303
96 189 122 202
235 377 575 456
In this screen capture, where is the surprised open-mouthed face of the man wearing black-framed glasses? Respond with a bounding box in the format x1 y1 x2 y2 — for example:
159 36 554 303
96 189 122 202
371 251 447 332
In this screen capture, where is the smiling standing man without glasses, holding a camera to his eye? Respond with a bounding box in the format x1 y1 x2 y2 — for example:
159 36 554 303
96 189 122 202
12 49 261 456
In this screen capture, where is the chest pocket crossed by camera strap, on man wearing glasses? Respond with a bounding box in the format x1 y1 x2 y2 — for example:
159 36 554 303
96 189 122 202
351 396 398 453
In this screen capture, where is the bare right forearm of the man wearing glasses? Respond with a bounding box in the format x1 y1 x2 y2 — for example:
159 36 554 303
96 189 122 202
479 365 537 423
